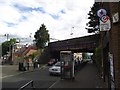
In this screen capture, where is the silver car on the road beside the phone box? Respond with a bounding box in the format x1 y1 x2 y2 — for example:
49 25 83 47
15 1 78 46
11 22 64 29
49 62 61 75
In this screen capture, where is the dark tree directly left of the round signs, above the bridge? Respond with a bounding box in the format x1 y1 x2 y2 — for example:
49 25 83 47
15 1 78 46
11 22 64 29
86 2 100 33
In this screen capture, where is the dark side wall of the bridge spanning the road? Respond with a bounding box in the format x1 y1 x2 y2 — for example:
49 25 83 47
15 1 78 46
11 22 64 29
49 35 98 51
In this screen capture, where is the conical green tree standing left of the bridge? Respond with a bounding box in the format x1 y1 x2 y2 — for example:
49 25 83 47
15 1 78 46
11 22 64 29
34 24 49 49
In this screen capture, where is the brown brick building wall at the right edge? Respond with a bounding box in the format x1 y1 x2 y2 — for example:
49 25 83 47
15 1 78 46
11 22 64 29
109 2 120 88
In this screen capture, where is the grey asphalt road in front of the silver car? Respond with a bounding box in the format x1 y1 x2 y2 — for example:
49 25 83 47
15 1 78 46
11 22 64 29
0 66 60 90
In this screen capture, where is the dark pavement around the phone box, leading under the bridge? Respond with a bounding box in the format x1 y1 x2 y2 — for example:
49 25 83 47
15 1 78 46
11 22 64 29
49 64 108 89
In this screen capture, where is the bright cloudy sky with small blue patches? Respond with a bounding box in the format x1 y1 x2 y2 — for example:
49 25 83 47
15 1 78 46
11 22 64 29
0 0 94 42
